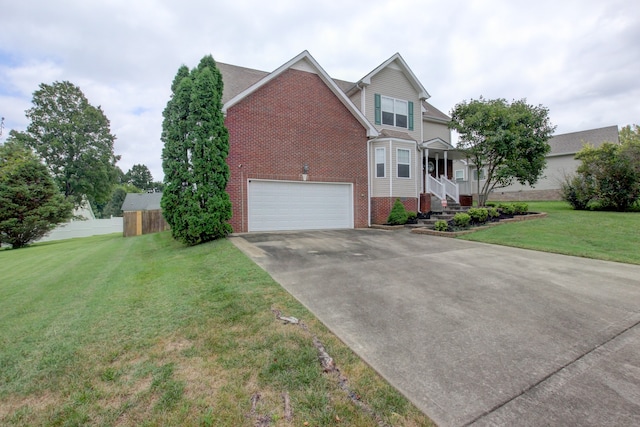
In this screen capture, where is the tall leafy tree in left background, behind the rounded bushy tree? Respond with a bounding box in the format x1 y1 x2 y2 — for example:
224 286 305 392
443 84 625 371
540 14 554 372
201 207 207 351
9 81 120 206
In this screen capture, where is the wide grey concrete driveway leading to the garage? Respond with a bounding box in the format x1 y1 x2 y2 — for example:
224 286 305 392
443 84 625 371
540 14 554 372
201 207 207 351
232 230 640 426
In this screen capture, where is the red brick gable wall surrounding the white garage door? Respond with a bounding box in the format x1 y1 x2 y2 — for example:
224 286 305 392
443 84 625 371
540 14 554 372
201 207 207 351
225 69 368 232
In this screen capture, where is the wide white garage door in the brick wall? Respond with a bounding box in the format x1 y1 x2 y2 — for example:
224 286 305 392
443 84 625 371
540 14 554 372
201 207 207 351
249 180 353 231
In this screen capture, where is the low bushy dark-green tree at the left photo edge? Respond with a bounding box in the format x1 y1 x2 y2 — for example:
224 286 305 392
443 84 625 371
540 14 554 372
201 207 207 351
0 142 73 249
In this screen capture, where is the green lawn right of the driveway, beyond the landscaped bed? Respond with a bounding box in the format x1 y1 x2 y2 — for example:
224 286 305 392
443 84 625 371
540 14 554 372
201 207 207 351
460 202 640 264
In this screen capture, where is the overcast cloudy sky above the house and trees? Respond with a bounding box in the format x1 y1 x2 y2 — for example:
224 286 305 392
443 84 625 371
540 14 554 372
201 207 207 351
0 0 640 180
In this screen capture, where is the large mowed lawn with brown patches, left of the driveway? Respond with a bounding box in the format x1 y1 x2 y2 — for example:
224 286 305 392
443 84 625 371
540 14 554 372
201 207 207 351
0 233 431 426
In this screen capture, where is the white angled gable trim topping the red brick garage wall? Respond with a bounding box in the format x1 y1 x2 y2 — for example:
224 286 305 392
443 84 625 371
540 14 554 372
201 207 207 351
222 50 378 137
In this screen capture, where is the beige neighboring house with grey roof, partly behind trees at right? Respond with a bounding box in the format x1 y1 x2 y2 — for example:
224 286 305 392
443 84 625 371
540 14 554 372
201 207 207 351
453 126 619 201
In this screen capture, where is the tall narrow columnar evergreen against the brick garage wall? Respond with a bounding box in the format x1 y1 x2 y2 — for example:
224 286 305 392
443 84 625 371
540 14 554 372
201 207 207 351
161 55 231 245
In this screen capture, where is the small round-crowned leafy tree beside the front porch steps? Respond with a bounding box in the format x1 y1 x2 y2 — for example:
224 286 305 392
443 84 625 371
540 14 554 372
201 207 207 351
449 97 555 206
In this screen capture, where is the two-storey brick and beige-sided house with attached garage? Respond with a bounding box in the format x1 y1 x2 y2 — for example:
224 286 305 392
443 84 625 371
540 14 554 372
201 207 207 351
218 51 459 232
